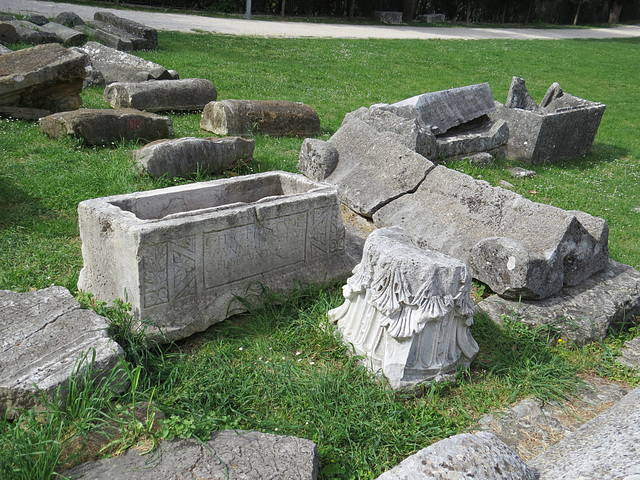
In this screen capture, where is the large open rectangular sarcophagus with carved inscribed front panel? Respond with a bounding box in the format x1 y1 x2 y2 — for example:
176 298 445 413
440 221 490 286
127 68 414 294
78 172 355 342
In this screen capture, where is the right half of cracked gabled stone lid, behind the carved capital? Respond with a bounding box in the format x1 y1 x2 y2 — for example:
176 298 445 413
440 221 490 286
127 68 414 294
373 166 609 299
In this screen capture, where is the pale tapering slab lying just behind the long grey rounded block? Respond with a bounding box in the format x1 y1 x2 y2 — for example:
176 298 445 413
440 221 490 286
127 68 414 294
79 42 173 84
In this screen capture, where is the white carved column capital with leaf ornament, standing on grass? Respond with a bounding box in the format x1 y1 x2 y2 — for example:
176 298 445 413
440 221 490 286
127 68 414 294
329 227 478 389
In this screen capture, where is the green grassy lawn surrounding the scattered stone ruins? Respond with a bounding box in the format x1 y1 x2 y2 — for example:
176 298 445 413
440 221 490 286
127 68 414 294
0 32 640 479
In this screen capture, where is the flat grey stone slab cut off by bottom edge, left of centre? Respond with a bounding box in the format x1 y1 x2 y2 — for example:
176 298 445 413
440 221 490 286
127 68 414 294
63 430 319 480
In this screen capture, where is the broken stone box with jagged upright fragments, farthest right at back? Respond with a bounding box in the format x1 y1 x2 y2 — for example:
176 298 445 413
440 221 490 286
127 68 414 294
491 76 606 164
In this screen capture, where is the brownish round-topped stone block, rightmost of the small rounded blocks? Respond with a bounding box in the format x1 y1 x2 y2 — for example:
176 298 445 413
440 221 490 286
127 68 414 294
200 100 320 137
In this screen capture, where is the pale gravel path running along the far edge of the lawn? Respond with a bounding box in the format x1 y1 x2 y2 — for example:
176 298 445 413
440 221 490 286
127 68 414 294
0 0 640 40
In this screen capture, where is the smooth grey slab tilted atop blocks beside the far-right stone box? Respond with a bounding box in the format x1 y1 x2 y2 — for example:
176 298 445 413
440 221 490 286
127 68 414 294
388 83 495 135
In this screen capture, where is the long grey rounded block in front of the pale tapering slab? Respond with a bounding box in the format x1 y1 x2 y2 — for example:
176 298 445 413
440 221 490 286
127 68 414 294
103 78 218 112
